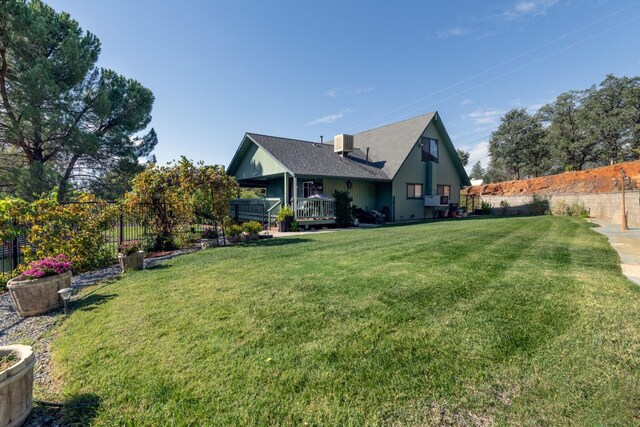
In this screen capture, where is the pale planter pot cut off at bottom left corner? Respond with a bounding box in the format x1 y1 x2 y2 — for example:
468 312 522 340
0 345 36 427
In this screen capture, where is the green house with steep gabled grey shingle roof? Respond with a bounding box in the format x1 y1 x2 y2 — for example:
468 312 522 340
227 112 470 225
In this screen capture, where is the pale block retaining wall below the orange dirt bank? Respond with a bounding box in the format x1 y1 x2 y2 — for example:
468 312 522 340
476 190 640 227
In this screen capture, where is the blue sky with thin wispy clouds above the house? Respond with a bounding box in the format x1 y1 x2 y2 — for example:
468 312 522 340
45 0 640 171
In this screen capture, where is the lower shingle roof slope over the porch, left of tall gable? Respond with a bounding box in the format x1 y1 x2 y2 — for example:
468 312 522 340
247 133 390 180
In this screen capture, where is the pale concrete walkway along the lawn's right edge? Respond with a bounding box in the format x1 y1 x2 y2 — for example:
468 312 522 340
590 218 640 285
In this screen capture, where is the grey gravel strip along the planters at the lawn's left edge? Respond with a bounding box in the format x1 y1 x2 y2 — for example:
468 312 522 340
0 248 198 426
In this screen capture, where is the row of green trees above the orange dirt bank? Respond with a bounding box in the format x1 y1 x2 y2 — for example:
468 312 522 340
483 75 640 182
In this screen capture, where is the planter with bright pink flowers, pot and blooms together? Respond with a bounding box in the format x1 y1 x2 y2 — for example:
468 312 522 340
7 254 71 317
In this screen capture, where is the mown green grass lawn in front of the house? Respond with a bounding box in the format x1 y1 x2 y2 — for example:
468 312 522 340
53 216 640 426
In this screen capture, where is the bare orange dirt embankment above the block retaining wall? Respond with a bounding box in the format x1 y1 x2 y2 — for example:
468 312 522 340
468 160 640 196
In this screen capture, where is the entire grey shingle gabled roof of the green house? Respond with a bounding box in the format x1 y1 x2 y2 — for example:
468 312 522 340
228 112 469 185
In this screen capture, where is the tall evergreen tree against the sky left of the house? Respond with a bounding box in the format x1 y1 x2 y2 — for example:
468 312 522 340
0 0 157 198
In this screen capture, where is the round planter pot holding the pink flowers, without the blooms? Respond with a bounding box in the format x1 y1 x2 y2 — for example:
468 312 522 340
7 271 71 317
